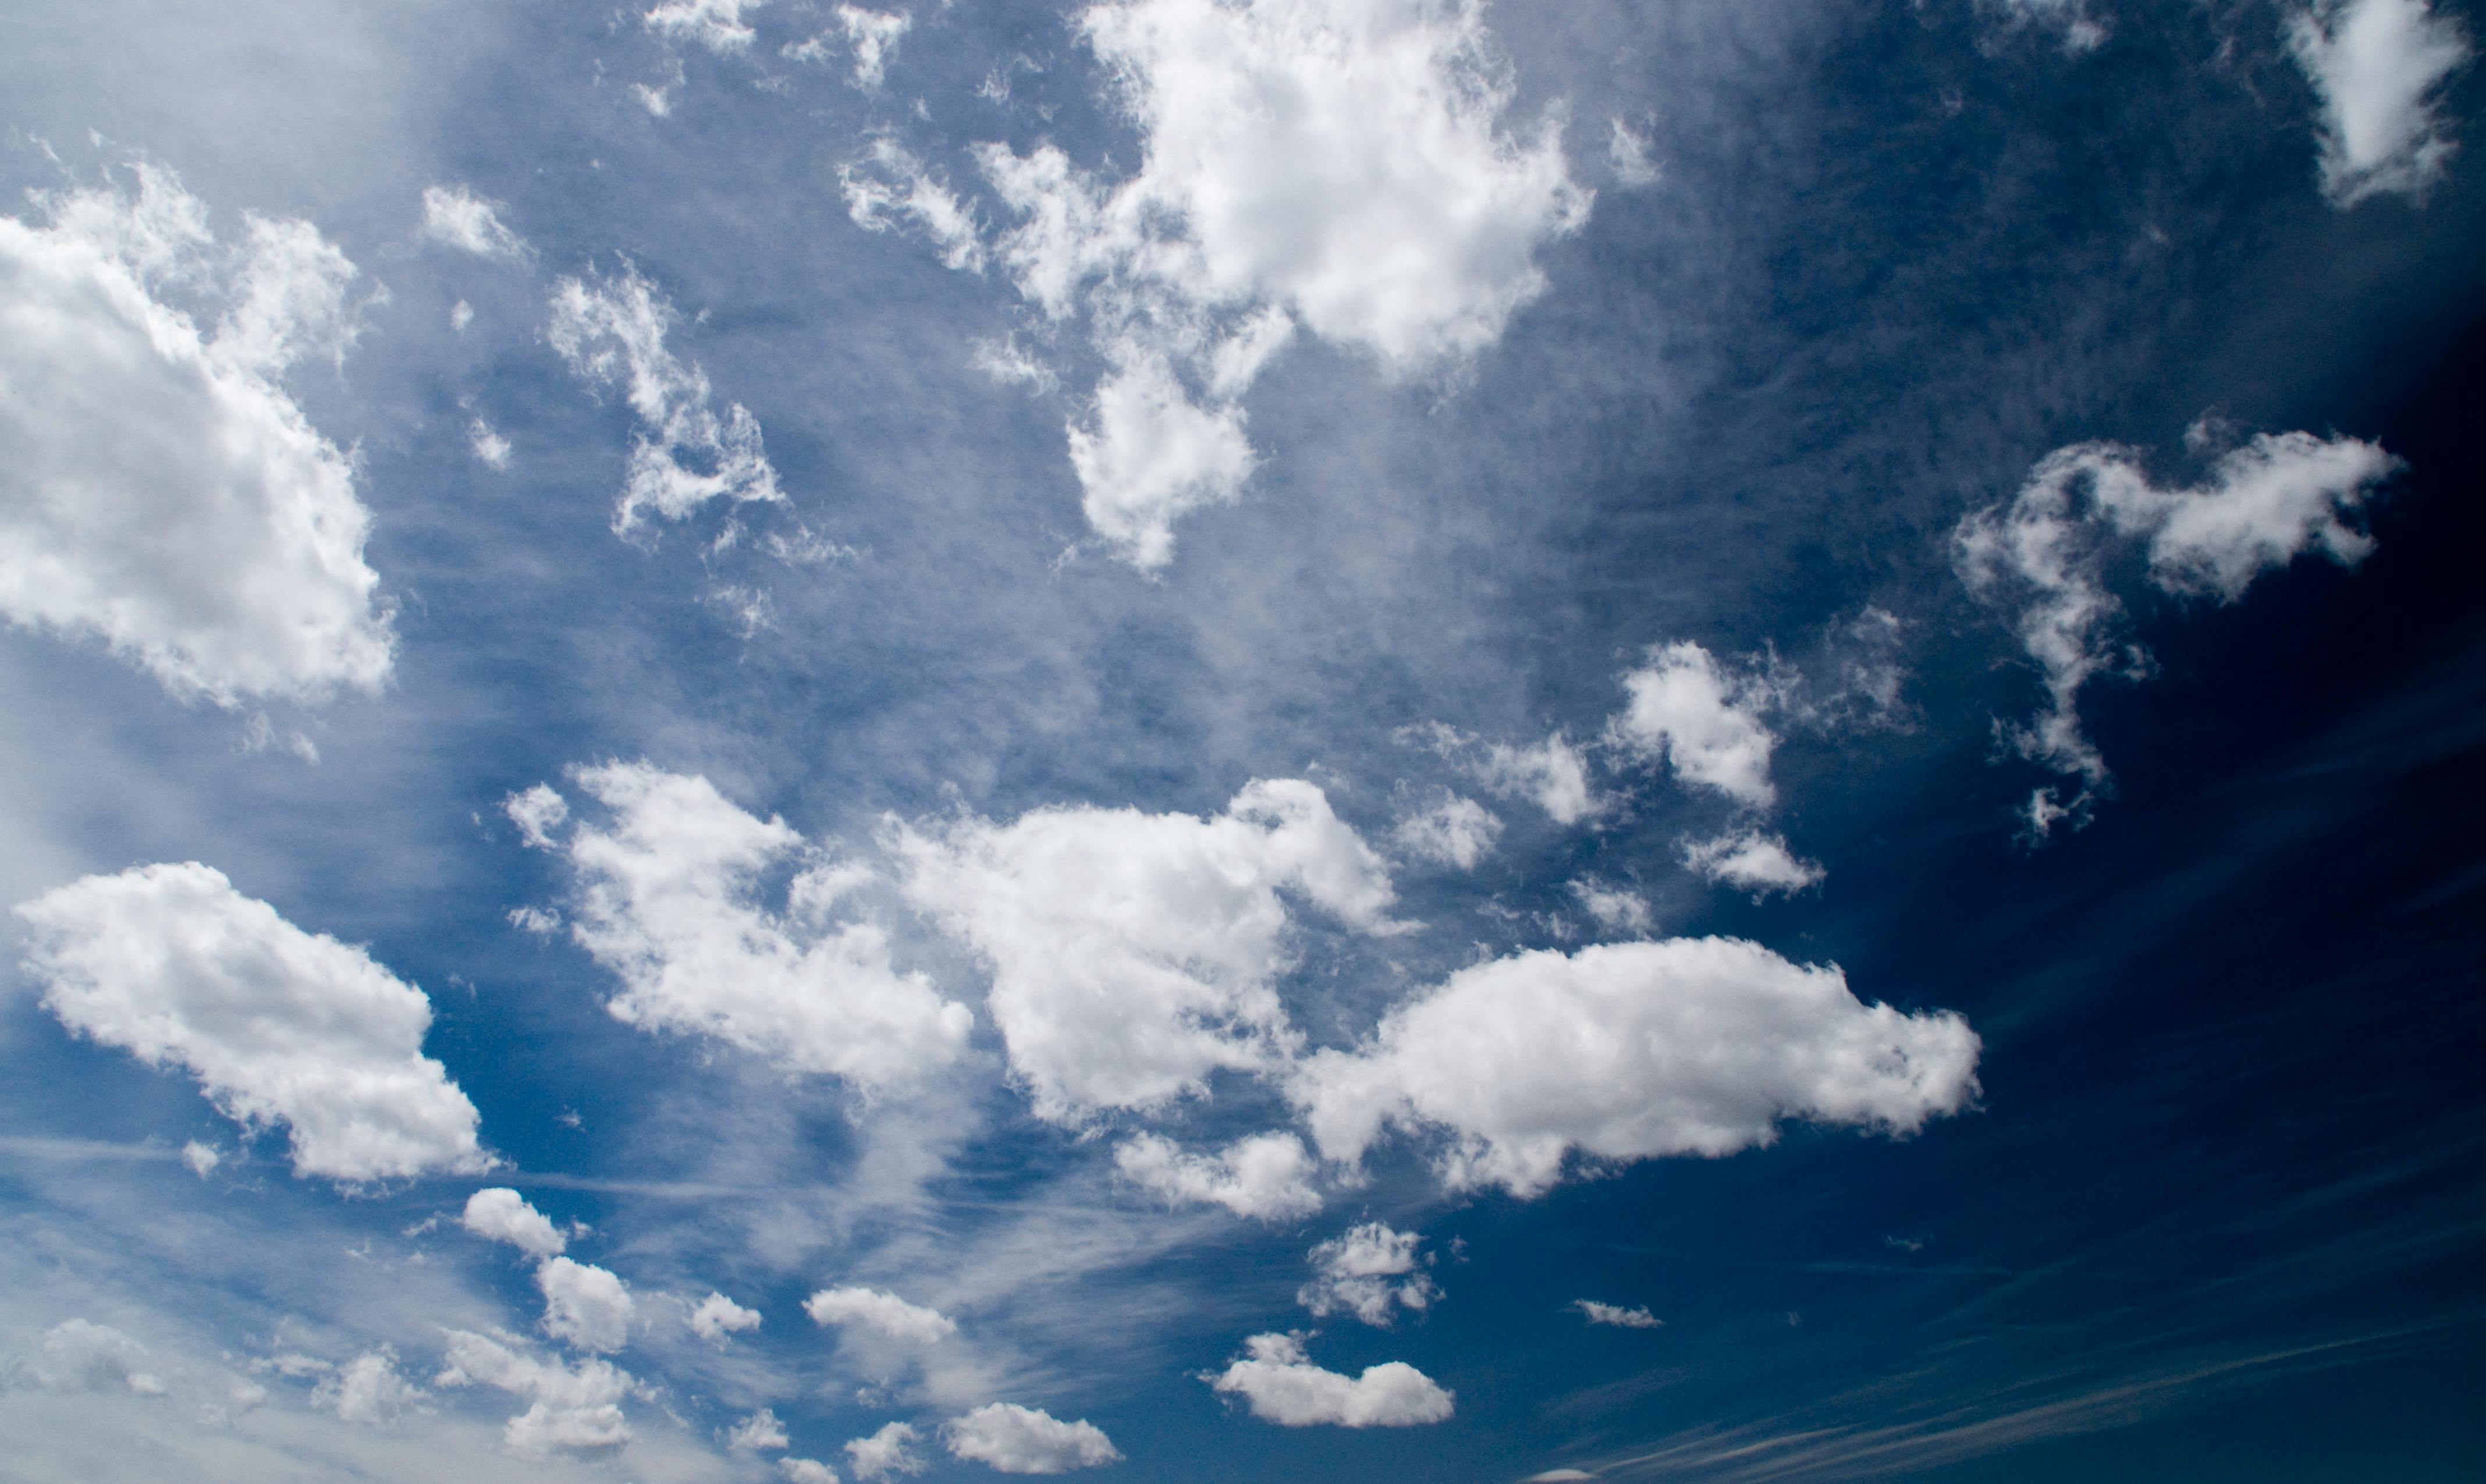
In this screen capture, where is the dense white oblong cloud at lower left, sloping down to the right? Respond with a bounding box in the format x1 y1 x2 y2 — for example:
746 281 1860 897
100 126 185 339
17 862 492 1183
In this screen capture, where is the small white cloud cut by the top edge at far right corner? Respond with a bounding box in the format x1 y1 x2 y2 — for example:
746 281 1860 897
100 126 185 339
2287 0 2471 209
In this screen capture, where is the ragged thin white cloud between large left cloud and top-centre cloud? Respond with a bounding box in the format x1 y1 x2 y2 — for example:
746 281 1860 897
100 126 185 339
545 261 786 534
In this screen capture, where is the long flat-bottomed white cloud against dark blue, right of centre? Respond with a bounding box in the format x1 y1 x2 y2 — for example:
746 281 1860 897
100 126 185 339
1295 937 1979 1196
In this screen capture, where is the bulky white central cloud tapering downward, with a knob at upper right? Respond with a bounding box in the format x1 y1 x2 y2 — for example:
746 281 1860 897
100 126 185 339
893 778 1395 1124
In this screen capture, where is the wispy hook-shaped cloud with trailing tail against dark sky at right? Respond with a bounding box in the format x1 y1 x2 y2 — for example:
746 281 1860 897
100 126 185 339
1952 432 2399 835
